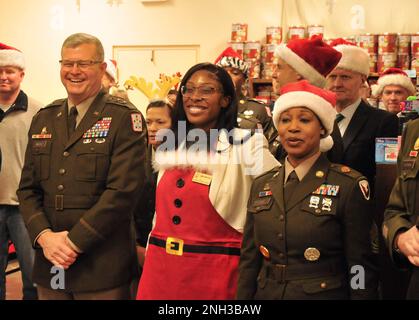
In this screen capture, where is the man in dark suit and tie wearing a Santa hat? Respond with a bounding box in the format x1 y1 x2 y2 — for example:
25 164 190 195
326 39 399 187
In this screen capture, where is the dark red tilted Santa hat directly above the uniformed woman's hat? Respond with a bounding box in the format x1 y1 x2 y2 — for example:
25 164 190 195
275 36 342 88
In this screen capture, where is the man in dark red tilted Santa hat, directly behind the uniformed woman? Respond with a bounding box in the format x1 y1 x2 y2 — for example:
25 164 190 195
272 36 343 163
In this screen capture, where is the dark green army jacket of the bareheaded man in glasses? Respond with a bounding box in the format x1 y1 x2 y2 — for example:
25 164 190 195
18 92 147 293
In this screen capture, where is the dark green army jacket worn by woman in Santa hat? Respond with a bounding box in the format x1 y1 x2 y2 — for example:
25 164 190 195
237 155 377 299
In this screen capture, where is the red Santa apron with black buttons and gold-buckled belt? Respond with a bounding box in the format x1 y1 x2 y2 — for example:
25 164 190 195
137 168 242 300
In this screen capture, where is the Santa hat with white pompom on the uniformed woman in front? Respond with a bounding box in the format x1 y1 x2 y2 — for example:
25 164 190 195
273 80 336 152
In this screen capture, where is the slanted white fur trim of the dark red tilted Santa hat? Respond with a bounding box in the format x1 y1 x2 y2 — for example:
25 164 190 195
275 44 326 88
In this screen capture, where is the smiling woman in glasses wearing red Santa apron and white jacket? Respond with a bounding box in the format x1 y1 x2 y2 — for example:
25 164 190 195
137 63 278 300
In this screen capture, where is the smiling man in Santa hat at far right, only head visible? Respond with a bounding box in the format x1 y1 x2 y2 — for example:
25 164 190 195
374 68 416 114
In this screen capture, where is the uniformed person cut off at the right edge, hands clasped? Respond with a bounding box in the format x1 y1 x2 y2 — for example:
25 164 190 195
383 119 419 299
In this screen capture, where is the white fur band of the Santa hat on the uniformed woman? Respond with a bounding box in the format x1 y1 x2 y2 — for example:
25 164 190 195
273 91 336 136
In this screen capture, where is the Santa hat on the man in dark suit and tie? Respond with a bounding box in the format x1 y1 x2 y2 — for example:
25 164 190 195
330 38 370 77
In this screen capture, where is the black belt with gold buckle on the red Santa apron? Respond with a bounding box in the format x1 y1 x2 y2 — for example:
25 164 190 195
148 237 240 256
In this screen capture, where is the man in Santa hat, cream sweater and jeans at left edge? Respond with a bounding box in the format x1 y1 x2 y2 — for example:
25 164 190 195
0 43 42 299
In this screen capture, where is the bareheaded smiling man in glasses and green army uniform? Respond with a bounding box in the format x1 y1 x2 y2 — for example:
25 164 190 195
18 33 147 300
